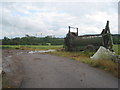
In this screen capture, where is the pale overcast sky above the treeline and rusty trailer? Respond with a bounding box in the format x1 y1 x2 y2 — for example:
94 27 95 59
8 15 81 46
0 0 118 38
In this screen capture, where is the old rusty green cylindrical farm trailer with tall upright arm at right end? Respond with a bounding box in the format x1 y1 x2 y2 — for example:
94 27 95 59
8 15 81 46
64 21 113 51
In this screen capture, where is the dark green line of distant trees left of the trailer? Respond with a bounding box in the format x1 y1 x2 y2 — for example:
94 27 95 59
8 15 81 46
2 35 64 45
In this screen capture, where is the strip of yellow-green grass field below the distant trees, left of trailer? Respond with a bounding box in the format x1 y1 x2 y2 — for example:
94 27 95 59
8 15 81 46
0 45 63 50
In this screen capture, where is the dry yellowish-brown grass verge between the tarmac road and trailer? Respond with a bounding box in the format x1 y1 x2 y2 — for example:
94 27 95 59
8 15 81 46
49 51 120 78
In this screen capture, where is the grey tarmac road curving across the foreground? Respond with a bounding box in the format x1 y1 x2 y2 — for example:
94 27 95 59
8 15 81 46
17 53 118 88
